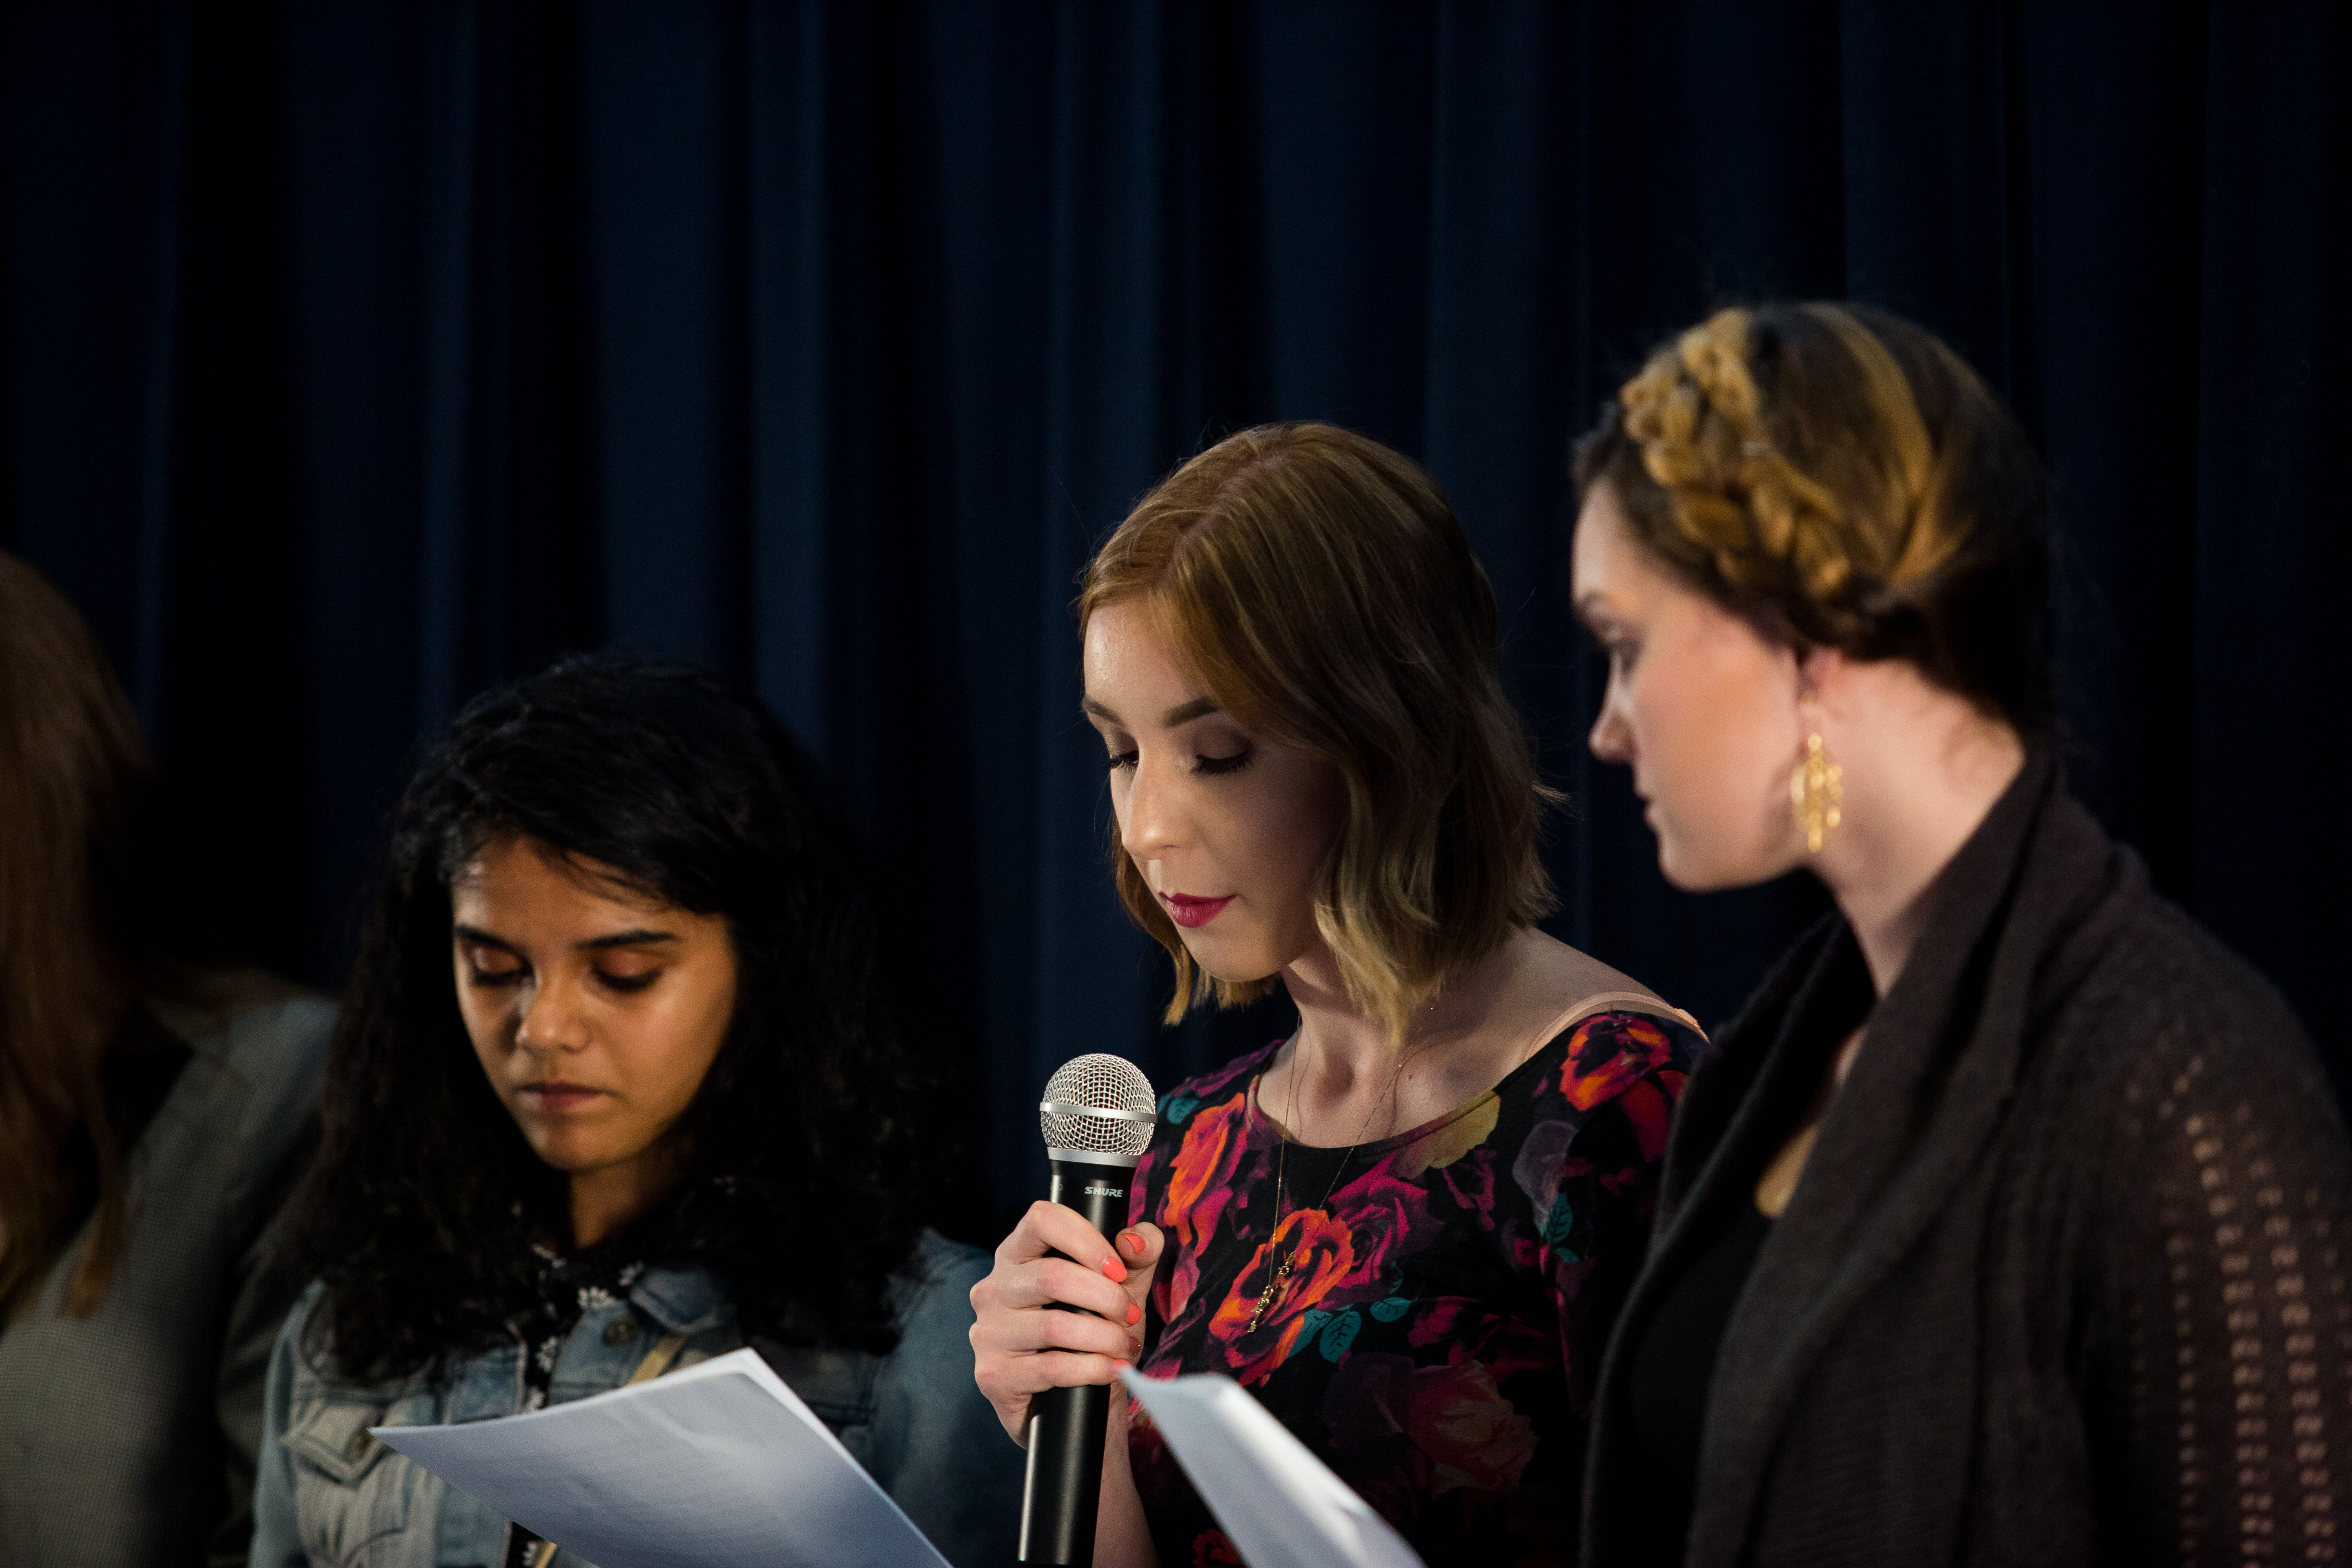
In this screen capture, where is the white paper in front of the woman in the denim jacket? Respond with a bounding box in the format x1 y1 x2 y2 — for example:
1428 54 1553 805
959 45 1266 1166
372 1350 948 1568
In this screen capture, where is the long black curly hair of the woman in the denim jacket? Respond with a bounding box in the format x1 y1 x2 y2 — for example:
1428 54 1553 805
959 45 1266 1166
294 656 941 1380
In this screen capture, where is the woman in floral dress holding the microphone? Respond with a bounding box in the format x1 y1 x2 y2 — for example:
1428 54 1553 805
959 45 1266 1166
971 423 1703 1568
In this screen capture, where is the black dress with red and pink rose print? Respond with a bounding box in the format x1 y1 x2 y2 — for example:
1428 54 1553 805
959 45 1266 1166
1129 1011 1705 1568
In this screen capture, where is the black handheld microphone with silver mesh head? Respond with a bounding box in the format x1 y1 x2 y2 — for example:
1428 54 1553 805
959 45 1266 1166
1018 1053 1157 1568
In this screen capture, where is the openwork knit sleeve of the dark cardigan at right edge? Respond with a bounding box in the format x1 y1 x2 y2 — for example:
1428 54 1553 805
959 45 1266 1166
2093 1025 2352 1563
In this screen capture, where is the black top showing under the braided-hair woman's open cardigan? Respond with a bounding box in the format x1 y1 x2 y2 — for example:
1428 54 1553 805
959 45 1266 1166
1632 1204 1771 1535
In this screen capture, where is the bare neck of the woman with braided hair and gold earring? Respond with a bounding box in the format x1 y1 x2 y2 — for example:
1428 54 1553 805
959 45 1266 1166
1816 693 2025 997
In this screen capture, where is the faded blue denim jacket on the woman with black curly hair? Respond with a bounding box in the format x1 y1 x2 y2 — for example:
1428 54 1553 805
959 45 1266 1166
252 1232 1023 1568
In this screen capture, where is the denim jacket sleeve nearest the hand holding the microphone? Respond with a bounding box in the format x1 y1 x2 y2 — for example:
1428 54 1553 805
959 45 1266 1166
856 1234 1025 1568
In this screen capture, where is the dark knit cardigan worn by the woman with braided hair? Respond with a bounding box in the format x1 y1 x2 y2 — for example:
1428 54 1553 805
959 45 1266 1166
1585 755 2352 1568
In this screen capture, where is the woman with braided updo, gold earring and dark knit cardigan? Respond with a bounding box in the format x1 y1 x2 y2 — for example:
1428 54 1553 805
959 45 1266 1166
1576 305 2352 1568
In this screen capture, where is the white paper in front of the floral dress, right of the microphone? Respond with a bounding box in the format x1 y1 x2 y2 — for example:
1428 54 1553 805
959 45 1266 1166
1122 1370 1423 1568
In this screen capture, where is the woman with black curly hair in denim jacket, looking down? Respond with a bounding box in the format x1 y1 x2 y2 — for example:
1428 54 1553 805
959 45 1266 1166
252 661 1018 1568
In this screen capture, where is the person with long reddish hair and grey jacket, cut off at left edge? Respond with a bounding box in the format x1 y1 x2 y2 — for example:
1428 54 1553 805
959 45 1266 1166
0 552 334 1568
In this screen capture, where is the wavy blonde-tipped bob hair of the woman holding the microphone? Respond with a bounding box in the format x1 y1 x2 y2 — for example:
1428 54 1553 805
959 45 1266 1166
1077 423 1557 1039
